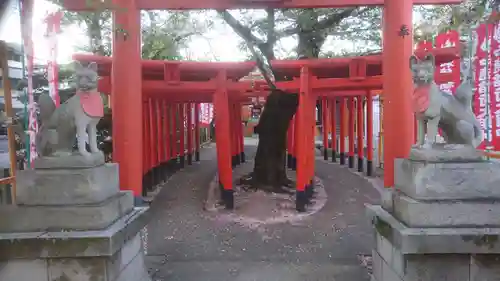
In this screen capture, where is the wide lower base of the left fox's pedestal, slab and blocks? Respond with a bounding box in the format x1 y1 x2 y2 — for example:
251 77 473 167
0 208 151 281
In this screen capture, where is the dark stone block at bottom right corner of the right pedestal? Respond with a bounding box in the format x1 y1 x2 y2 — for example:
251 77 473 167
469 255 500 281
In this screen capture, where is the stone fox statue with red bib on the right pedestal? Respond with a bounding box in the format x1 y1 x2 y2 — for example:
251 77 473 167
410 54 483 147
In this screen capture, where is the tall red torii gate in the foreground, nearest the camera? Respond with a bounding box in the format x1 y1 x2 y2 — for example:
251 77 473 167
63 0 461 208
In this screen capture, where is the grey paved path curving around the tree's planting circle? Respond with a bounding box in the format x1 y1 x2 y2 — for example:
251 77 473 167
146 138 379 281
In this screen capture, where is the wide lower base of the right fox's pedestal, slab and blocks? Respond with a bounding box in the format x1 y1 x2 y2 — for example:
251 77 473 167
367 203 500 281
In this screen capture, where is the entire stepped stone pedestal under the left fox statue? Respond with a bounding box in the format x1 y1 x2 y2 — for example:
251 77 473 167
0 164 150 281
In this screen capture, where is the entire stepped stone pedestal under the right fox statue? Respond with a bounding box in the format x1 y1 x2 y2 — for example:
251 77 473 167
367 150 500 281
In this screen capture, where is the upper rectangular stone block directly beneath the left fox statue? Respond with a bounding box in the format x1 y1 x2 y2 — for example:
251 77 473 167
16 164 120 206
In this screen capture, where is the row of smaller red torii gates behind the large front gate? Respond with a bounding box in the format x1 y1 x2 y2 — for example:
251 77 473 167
74 47 460 211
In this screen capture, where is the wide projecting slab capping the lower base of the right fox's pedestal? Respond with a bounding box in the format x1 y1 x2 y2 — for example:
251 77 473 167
366 205 500 255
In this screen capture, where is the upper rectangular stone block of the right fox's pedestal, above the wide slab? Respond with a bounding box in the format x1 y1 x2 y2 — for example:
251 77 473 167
394 159 500 200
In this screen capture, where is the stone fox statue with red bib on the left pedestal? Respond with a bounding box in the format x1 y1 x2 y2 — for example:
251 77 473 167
37 62 104 157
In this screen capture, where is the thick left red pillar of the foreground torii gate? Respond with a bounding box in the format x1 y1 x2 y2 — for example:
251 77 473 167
111 0 143 203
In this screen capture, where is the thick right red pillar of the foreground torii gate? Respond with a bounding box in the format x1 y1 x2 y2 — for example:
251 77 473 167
382 0 414 187
